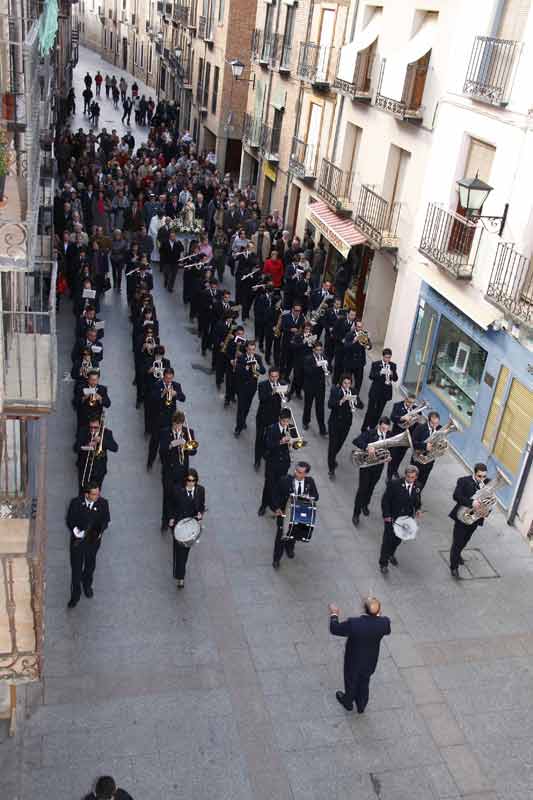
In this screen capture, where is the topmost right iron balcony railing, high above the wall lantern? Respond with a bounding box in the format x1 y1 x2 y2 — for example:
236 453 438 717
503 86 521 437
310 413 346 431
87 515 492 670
463 36 520 106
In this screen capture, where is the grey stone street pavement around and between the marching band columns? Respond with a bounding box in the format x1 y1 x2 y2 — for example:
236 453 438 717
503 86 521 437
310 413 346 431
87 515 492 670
4 49 533 800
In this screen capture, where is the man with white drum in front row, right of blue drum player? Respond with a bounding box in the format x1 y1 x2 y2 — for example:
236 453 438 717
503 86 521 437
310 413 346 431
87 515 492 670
379 465 421 575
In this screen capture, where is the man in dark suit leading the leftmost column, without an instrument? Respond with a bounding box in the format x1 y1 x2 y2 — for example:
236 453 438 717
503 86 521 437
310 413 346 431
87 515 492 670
66 483 111 608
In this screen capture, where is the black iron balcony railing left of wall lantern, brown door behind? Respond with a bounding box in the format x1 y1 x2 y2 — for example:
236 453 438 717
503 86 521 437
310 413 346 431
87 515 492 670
418 203 480 280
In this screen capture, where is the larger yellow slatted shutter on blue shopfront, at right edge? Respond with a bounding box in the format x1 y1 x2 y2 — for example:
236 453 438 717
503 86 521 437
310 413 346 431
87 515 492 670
493 379 533 475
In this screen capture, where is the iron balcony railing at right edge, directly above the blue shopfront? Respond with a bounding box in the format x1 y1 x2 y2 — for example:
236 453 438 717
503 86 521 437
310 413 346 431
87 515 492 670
487 242 533 329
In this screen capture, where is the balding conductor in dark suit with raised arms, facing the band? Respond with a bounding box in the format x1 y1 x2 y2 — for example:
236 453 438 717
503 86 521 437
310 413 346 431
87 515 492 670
329 597 391 714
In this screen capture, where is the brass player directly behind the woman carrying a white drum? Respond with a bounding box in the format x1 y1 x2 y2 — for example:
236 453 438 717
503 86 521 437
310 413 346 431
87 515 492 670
159 411 196 532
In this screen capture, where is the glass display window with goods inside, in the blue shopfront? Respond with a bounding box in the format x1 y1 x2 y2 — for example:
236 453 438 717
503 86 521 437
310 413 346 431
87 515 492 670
428 317 487 426
